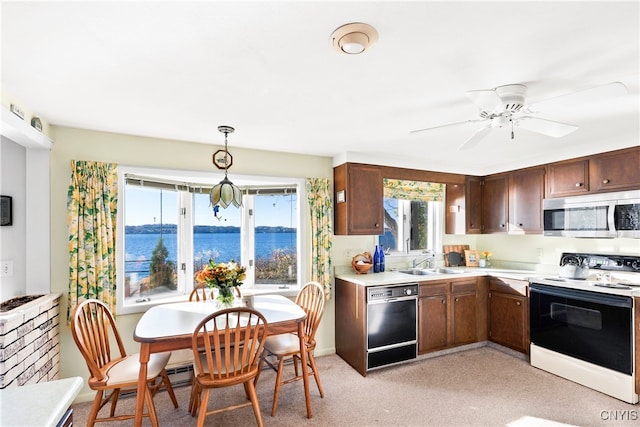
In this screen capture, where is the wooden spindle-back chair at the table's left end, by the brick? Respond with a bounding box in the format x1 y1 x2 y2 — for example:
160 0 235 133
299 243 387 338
71 299 178 426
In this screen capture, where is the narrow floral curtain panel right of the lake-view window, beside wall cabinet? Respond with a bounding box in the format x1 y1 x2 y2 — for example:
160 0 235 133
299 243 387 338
306 178 333 299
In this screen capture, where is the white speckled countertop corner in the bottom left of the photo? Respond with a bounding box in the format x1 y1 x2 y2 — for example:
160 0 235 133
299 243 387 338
0 377 83 427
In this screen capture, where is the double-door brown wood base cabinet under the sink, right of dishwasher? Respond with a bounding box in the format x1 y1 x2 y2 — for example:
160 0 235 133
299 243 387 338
418 277 479 354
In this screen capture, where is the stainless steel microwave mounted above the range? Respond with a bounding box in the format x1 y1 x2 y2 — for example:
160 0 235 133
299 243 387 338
542 190 640 239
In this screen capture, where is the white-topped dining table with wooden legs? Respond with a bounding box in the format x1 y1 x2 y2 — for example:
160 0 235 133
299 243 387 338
133 295 312 426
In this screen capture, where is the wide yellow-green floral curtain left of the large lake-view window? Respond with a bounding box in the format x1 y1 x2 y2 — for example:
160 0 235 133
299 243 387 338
67 160 118 321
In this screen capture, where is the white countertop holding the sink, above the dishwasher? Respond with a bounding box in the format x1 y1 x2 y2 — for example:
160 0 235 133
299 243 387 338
336 267 540 286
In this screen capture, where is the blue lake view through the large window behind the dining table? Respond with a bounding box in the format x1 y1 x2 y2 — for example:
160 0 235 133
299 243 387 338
124 186 298 300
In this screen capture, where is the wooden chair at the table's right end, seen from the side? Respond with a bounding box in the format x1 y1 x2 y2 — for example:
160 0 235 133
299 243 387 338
255 282 325 417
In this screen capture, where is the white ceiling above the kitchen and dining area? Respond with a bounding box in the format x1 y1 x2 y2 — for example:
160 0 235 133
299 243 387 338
1 0 640 175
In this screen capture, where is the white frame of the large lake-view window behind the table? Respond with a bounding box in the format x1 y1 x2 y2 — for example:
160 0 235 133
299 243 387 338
116 165 311 315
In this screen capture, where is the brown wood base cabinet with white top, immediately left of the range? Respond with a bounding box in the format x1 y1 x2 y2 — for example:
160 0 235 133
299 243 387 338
489 278 529 354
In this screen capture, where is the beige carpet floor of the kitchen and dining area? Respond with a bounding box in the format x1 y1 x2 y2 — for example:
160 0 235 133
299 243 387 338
73 346 640 427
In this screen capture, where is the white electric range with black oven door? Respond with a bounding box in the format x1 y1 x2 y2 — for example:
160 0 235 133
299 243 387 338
529 253 640 403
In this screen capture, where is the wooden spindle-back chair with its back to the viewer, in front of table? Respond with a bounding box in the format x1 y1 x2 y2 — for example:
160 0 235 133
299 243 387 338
191 307 268 427
